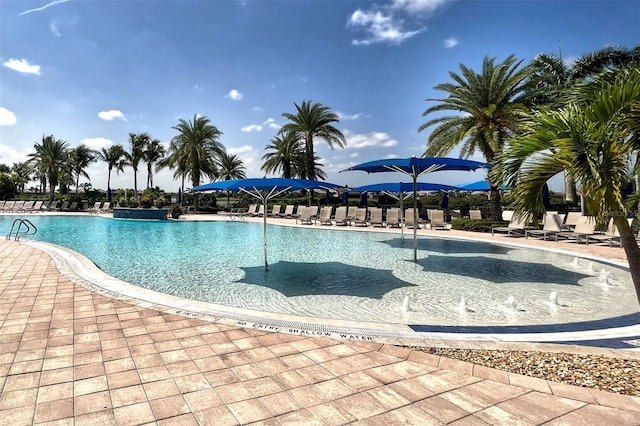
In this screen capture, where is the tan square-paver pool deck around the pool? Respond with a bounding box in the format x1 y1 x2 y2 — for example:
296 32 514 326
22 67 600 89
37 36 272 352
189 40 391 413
0 211 640 426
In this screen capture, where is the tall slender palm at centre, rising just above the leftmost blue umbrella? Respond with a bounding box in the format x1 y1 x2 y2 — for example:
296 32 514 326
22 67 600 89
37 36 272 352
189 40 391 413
279 101 347 180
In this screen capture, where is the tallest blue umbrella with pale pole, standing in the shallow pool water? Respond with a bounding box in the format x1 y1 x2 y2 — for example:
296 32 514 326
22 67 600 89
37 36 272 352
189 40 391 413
342 157 491 262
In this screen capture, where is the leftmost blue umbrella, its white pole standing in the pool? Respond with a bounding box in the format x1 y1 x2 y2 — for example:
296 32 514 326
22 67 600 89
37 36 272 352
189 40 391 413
191 178 340 269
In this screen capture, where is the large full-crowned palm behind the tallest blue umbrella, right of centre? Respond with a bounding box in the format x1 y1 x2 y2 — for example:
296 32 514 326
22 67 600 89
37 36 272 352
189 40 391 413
418 55 529 220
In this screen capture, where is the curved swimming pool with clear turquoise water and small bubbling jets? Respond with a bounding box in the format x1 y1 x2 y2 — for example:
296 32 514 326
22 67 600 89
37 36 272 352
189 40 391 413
0 216 637 325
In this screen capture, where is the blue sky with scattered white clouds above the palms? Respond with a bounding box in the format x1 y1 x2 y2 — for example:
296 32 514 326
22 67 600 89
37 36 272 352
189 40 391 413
0 0 640 191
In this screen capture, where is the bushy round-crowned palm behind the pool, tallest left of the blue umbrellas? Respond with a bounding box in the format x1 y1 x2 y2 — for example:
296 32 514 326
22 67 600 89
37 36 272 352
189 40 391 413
169 115 224 190
